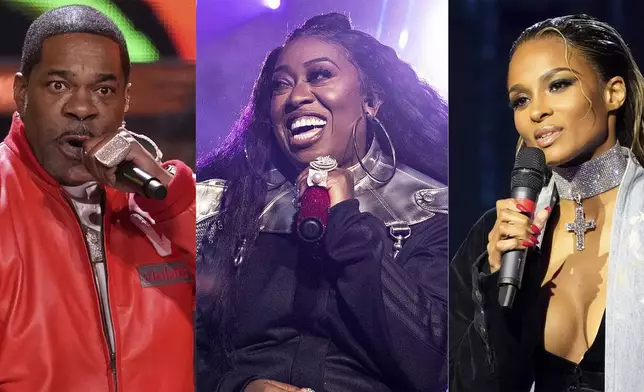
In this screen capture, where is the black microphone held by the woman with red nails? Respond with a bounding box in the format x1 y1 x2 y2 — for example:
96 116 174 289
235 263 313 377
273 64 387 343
498 147 548 308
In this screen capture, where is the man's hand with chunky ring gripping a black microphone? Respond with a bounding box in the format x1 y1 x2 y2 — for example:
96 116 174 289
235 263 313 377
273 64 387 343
83 128 172 200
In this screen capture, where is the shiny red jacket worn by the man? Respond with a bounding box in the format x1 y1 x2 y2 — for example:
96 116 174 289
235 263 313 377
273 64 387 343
0 119 195 392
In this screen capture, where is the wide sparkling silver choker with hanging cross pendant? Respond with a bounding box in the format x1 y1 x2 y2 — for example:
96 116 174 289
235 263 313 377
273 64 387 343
552 143 628 250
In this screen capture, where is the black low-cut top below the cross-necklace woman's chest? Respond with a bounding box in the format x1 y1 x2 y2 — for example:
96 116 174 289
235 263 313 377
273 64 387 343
535 312 606 392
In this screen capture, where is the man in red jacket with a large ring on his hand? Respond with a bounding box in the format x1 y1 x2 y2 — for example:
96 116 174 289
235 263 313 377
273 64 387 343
0 6 195 392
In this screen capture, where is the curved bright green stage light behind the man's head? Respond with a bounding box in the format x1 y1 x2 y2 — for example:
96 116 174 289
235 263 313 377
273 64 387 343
7 0 159 63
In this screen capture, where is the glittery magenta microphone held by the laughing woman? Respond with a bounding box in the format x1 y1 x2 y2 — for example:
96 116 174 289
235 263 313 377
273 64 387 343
296 186 331 242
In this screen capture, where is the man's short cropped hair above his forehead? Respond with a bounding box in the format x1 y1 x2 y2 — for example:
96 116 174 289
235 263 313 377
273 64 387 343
20 5 130 81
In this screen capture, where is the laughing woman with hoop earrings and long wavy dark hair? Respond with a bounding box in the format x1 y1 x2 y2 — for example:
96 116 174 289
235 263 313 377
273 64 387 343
196 14 448 392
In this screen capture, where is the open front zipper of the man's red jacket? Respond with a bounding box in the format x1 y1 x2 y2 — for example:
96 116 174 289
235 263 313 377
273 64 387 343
63 193 119 392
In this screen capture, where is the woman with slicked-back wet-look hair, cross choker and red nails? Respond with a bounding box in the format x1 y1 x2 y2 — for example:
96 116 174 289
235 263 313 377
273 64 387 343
450 15 644 392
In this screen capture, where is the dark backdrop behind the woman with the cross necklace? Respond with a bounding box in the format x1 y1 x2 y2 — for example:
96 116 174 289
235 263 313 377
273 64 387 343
449 0 644 256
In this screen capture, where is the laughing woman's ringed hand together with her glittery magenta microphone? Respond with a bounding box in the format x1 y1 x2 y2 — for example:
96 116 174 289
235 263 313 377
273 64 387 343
296 156 354 242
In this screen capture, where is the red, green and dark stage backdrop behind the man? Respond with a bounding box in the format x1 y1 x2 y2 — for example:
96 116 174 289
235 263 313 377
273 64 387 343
0 0 196 167
